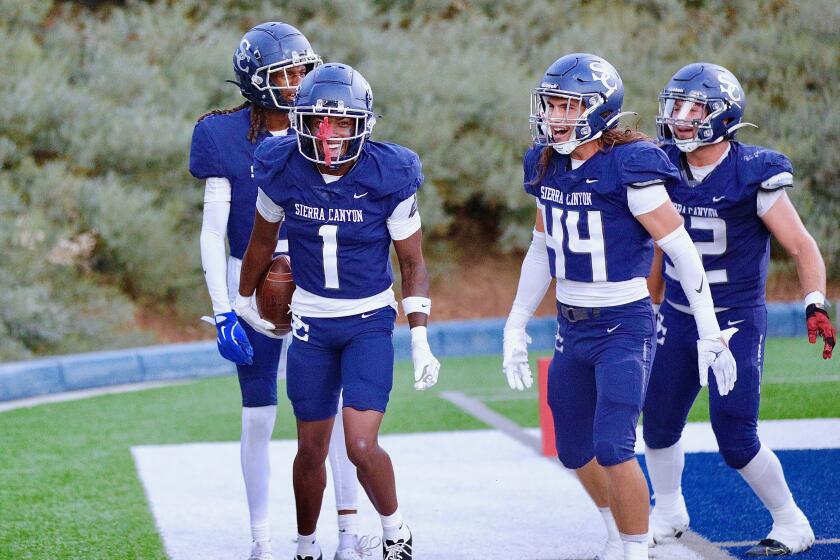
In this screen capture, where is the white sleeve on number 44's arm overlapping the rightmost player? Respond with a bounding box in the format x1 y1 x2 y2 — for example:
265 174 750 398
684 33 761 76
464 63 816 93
656 226 720 338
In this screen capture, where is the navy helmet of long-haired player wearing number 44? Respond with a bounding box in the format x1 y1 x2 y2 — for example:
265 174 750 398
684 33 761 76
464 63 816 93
529 53 626 154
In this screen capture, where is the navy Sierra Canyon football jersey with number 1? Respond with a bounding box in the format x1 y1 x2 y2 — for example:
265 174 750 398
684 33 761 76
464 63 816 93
249 137 423 299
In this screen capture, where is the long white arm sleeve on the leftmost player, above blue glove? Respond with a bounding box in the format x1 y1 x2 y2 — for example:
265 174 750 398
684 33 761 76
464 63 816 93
200 177 231 314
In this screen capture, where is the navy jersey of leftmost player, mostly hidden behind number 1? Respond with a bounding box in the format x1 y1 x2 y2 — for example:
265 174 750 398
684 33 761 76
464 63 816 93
190 107 286 259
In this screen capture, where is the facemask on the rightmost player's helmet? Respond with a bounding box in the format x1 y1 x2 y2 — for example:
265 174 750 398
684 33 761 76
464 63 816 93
656 92 728 152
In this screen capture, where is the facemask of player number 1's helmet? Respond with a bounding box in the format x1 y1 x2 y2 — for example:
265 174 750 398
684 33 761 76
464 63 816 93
292 100 376 169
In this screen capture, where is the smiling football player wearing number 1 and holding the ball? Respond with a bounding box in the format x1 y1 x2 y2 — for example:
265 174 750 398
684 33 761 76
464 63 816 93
234 64 440 560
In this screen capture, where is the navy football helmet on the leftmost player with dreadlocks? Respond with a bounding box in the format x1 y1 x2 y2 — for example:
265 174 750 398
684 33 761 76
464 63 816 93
233 21 322 110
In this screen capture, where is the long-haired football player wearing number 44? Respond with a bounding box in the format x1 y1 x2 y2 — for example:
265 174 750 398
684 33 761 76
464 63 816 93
503 53 736 560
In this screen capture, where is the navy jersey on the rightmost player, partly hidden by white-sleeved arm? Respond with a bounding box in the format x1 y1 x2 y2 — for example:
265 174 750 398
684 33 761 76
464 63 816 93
664 142 793 307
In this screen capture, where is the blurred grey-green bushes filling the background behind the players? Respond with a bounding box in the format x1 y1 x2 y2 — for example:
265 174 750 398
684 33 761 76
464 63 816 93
0 0 840 359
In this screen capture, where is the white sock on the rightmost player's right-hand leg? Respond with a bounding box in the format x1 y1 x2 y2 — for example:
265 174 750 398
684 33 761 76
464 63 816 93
738 445 799 524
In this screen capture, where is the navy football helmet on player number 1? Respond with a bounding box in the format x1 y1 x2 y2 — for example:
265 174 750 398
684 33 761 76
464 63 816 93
291 62 376 168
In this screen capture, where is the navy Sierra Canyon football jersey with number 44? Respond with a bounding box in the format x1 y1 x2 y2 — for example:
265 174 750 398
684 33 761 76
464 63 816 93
524 142 679 282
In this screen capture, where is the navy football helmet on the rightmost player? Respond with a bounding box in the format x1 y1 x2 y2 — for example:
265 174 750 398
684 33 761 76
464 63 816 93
656 62 755 152
